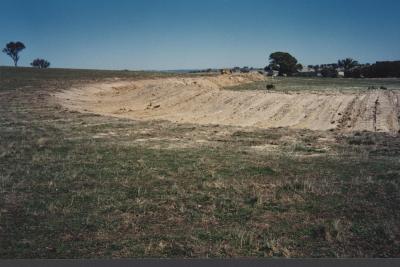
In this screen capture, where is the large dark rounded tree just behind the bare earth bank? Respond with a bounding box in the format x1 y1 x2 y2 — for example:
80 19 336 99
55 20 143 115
266 52 301 75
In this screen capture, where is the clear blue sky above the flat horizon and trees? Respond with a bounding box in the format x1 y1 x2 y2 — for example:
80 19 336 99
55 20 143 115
0 0 400 70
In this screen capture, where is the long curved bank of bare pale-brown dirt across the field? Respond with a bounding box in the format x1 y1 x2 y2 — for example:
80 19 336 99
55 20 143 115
56 74 400 133
